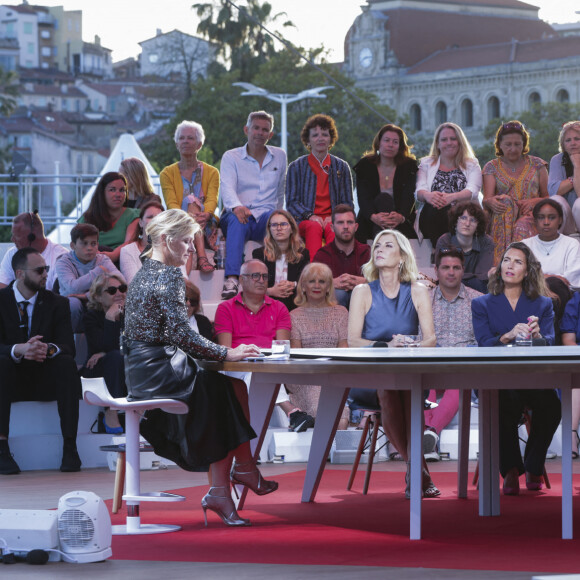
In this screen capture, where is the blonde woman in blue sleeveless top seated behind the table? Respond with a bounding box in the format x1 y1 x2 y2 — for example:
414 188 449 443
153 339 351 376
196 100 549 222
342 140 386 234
348 230 441 499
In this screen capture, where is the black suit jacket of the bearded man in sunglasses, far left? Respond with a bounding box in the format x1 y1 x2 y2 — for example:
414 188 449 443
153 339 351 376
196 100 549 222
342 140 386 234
0 283 75 357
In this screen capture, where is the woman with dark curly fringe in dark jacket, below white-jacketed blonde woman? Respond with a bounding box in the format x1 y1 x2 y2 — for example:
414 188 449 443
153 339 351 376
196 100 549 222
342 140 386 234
435 201 493 294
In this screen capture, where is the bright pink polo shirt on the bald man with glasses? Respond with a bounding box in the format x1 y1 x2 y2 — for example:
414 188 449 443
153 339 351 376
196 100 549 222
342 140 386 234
214 292 292 348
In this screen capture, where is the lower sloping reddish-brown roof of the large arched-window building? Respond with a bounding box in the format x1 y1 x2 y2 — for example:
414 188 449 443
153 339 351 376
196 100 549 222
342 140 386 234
407 36 580 74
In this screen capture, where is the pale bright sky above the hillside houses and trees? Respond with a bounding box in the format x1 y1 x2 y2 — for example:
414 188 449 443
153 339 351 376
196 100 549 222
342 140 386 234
36 0 580 62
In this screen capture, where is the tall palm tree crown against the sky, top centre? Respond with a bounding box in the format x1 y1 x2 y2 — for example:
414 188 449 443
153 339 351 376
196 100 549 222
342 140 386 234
193 0 294 81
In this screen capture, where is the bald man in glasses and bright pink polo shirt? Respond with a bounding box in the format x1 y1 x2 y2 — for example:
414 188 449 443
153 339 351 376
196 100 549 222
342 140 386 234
214 260 314 431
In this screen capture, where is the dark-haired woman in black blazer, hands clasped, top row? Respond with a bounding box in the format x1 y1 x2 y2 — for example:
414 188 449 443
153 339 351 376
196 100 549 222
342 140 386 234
353 124 417 243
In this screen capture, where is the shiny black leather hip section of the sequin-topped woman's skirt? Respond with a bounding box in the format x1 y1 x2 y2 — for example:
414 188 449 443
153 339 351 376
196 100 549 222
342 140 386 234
123 337 198 402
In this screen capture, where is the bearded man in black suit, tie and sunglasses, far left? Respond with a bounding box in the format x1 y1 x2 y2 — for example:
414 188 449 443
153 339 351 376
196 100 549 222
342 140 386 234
0 248 81 475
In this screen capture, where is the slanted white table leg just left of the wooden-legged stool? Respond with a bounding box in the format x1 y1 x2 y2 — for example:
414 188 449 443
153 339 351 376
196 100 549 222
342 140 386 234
302 385 349 502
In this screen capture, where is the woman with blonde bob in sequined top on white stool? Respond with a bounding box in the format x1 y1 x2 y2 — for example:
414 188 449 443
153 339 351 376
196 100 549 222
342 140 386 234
124 209 278 526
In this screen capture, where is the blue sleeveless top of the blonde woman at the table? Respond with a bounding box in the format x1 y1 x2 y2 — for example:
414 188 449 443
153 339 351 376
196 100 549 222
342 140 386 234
362 280 419 341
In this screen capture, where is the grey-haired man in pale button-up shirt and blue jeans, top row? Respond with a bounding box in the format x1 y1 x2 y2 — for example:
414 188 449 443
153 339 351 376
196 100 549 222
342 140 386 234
220 111 287 300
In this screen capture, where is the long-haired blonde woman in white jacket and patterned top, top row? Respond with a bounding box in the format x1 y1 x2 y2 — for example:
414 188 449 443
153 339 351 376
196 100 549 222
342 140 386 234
415 123 481 247
